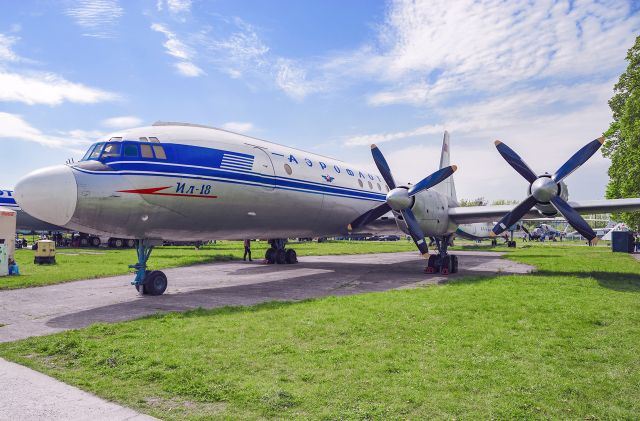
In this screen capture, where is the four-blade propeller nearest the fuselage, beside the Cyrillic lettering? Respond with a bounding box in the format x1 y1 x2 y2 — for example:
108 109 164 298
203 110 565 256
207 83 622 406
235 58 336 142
348 145 458 255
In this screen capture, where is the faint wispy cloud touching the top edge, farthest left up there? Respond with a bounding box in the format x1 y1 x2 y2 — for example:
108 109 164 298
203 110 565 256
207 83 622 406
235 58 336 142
65 0 124 38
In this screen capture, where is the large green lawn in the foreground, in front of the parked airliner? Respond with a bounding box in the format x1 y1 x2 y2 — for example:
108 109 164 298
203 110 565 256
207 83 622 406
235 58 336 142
0 244 640 419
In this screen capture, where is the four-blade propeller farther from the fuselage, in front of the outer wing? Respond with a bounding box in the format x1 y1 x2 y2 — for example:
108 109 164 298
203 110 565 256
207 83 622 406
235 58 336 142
492 137 604 241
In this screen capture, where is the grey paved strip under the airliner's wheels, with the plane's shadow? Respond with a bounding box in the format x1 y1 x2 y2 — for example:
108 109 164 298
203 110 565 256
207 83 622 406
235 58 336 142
0 252 532 342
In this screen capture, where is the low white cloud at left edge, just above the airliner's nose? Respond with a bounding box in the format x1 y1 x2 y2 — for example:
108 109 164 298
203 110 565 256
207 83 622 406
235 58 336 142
0 112 97 151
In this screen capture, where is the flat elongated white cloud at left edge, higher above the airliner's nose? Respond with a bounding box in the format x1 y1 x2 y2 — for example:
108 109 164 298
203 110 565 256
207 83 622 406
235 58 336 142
0 69 119 105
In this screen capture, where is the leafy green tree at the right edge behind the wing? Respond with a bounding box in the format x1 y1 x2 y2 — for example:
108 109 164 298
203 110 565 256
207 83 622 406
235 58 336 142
602 36 640 227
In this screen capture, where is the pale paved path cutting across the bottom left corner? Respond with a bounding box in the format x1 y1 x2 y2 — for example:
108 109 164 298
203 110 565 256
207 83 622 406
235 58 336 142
0 358 156 421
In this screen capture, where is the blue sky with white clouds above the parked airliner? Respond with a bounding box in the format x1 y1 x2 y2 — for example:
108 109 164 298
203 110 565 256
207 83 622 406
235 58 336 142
0 0 640 200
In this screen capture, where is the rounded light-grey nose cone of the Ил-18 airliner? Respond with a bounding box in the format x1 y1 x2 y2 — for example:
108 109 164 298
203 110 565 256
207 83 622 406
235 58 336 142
13 165 78 226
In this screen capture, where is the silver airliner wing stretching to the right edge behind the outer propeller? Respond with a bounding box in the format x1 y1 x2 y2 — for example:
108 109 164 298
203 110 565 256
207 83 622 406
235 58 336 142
449 198 640 224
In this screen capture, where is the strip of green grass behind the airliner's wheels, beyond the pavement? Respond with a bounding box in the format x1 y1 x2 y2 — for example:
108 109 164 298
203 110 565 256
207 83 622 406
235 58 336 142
0 241 415 290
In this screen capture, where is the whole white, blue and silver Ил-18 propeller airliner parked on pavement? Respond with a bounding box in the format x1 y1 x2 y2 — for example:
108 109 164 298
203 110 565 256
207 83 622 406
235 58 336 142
14 122 640 295
